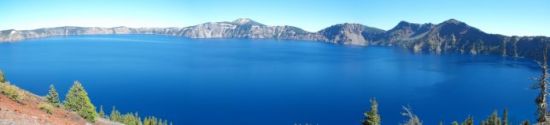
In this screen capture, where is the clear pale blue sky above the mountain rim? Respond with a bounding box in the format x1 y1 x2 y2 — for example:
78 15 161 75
0 0 550 36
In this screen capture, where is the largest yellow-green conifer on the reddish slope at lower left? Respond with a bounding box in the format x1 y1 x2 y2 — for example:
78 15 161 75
65 81 97 122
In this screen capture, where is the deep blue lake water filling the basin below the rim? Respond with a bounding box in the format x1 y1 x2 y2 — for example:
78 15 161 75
0 35 538 125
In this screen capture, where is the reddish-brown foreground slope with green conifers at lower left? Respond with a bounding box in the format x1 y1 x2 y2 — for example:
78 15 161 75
0 71 172 125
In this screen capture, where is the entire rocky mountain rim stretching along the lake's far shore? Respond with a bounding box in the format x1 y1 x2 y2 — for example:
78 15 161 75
0 18 550 59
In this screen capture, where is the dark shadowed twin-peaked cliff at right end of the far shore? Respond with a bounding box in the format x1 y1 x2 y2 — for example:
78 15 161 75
378 19 550 59
